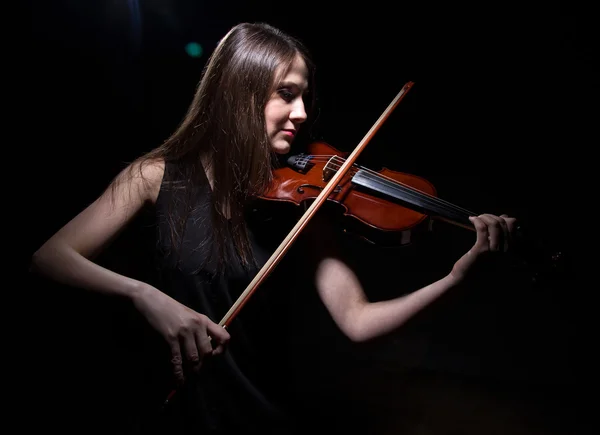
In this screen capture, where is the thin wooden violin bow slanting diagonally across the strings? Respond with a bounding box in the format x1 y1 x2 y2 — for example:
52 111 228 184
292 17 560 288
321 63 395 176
219 81 414 328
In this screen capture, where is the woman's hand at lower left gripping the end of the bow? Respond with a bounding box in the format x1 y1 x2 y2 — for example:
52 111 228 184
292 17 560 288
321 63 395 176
134 287 230 382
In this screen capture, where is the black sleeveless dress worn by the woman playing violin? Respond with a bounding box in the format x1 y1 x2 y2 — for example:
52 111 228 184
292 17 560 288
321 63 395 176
143 163 318 435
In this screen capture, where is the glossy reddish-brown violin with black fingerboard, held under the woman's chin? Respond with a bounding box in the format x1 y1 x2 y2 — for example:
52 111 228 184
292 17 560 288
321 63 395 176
261 142 565 284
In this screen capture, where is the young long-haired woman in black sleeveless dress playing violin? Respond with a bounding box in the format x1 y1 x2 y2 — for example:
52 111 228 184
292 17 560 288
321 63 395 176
32 24 515 434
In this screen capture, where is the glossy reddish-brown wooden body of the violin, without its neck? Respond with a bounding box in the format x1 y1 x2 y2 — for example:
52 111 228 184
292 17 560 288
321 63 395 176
261 142 468 246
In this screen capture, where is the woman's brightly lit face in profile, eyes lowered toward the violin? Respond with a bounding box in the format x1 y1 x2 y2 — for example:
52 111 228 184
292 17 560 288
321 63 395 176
265 56 308 154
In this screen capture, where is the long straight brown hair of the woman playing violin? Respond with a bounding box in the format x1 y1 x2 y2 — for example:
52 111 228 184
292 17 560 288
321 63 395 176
118 23 315 272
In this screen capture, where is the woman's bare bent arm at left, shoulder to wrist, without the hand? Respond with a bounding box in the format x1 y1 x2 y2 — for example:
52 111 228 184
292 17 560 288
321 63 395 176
32 162 164 299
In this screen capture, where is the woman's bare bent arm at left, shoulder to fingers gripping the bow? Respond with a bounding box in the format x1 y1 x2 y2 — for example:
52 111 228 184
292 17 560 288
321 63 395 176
31 162 230 381
